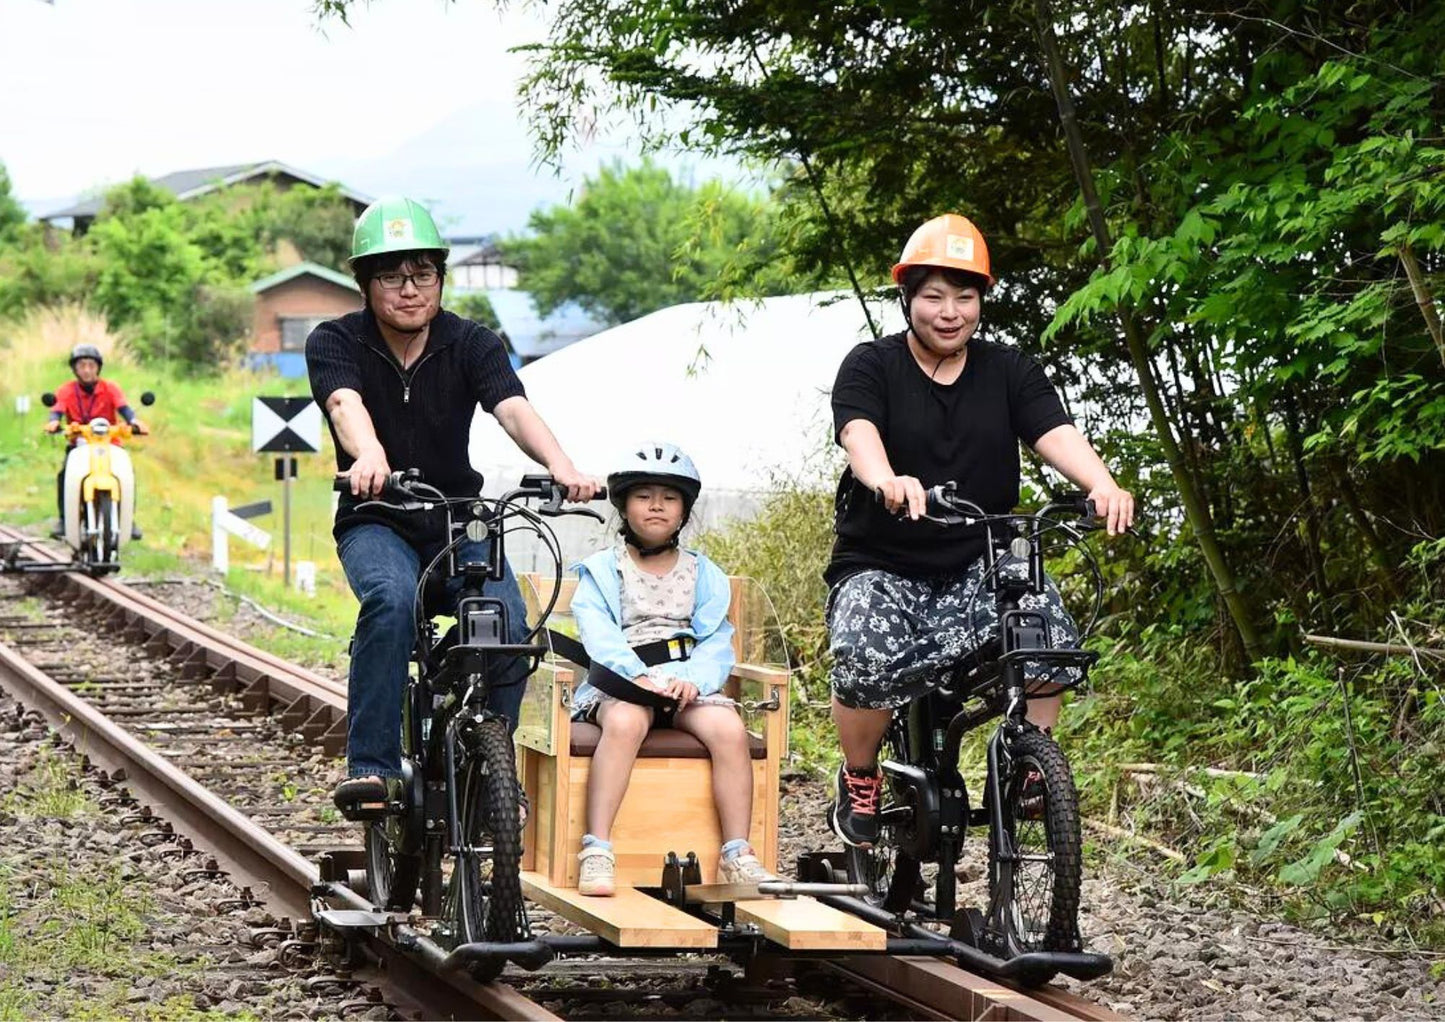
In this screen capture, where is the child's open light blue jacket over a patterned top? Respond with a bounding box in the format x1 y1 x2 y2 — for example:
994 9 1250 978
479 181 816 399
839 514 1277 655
572 546 737 707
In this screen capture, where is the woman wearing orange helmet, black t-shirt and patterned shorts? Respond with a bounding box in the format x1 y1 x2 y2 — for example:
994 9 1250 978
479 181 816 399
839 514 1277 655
825 212 1134 847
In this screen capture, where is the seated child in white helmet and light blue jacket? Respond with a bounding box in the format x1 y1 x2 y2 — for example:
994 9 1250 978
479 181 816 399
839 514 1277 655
572 444 777 896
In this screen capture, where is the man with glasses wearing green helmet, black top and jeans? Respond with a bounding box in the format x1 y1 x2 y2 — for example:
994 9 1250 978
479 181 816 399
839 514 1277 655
306 198 598 804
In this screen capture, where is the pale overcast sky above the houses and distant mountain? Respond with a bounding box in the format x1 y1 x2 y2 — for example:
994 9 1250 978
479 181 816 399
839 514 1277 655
0 0 728 233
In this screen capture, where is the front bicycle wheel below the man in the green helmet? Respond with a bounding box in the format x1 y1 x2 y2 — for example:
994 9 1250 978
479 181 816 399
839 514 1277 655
442 720 530 983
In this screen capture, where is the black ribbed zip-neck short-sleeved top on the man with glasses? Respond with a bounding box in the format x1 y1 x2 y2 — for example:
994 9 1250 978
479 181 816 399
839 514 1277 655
306 311 525 544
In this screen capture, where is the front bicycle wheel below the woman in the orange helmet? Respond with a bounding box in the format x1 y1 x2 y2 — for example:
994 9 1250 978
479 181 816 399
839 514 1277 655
988 727 1084 957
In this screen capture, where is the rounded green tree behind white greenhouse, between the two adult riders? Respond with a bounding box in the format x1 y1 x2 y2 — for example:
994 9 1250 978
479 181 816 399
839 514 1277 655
501 162 788 322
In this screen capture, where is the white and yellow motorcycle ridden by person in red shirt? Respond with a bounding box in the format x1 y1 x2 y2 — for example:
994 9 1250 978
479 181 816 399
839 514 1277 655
40 390 156 575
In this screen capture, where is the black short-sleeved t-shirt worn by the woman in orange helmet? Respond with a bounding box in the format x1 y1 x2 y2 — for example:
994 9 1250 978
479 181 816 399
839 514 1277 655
824 334 1071 585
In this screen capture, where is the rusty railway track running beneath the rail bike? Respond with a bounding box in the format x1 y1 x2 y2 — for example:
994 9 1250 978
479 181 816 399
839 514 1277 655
0 526 1118 1021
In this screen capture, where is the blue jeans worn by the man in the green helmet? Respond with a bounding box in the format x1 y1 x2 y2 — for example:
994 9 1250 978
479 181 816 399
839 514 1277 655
337 522 527 778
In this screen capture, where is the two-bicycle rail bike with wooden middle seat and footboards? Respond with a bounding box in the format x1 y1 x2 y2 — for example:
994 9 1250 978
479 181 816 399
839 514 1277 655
318 477 1111 986
